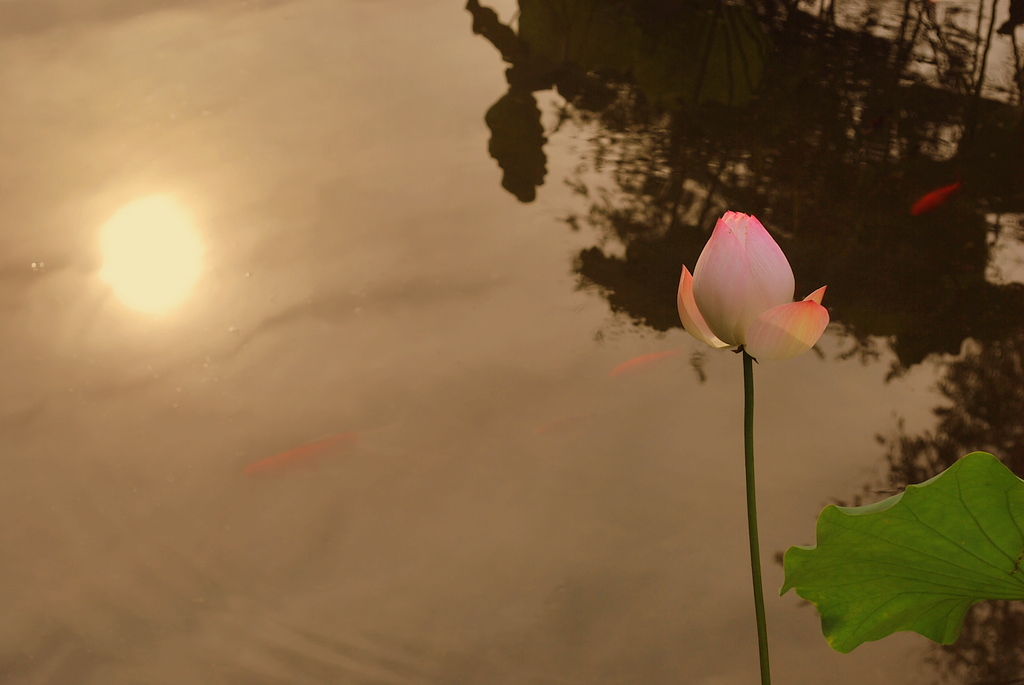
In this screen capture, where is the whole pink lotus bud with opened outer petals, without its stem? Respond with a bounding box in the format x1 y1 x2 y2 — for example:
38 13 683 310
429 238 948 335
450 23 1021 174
677 212 828 359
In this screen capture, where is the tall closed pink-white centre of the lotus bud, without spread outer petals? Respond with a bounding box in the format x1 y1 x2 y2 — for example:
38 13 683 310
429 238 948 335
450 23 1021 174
693 212 794 345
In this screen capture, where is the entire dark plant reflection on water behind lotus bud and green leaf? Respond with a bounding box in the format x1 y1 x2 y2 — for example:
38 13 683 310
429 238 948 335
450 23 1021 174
467 0 1024 684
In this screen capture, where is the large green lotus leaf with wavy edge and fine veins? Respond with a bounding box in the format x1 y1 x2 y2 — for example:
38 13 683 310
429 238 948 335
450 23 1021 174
781 452 1024 653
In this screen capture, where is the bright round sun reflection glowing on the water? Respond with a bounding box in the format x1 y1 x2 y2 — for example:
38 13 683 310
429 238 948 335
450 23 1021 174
99 196 203 314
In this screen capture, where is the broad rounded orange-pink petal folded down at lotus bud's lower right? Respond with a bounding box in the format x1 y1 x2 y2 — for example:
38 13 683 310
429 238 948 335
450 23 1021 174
743 299 828 359
